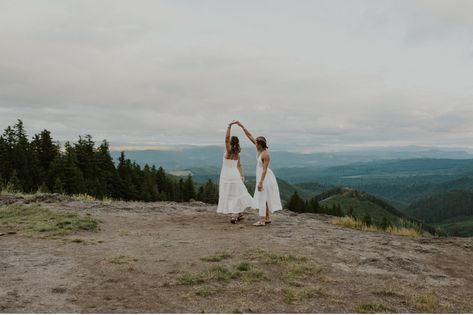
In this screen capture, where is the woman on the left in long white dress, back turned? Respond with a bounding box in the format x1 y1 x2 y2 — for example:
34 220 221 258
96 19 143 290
217 121 253 223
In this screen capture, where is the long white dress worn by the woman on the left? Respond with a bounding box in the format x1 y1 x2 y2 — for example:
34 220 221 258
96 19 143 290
217 155 253 214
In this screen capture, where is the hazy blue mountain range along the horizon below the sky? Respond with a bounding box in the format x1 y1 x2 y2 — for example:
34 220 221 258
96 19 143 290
111 145 473 172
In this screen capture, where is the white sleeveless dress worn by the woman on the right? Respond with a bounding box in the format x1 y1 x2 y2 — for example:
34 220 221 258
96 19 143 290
254 154 282 217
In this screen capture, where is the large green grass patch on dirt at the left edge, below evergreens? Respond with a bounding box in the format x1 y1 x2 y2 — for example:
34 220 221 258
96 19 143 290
0 205 98 237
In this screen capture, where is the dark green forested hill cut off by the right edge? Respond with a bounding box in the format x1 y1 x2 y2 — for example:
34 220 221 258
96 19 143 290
404 190 473 236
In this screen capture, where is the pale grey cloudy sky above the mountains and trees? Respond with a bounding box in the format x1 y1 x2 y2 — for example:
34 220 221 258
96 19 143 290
0 0 473 150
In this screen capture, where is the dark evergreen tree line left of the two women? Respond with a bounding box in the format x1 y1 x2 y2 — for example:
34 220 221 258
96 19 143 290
0 120 218 203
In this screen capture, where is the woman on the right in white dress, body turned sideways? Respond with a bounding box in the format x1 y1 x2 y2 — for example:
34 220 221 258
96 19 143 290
236 121 282 226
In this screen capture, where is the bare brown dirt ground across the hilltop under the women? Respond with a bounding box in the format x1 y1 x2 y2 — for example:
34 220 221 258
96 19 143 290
0 197 473 313
